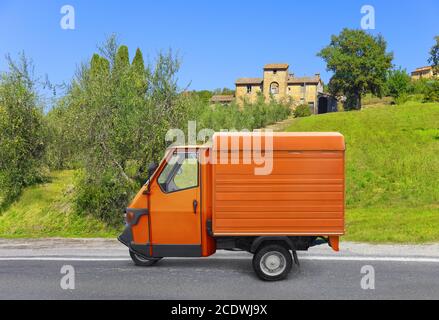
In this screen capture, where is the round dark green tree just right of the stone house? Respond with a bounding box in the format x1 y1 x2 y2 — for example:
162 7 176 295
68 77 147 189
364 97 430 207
318 29 393 110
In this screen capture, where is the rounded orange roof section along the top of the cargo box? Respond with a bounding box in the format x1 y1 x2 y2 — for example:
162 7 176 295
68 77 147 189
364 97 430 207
213 132 346 151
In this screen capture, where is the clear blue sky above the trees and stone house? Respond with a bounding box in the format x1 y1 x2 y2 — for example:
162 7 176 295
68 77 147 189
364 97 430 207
0 0 439 90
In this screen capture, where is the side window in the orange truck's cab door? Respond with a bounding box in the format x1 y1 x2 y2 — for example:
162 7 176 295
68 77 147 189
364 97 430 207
157 152 199 193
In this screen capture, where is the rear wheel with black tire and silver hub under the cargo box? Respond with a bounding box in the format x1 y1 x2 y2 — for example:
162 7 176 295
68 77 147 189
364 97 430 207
253 244 293 281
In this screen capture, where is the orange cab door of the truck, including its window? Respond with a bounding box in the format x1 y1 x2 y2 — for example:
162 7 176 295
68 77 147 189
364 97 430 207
150 150 201 257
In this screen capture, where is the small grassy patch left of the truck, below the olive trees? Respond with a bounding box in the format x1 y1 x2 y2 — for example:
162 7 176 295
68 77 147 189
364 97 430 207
0 171 118 238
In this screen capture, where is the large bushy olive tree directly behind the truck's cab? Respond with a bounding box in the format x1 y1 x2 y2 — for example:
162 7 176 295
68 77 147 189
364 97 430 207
49 42 184 223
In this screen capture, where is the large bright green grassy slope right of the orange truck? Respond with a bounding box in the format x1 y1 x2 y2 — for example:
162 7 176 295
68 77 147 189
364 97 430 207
286 102 439 243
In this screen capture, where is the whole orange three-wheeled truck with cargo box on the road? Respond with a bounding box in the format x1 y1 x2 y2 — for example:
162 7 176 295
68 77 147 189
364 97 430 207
119 133 345 281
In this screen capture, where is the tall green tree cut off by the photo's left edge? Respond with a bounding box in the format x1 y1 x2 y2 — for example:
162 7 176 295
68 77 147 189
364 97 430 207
0 55 46 207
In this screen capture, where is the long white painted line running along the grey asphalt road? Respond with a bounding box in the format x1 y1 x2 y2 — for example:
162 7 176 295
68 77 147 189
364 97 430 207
0 255 439 263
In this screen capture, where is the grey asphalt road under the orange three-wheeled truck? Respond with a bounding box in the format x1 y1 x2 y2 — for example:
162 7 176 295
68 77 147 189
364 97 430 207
0 240 439 300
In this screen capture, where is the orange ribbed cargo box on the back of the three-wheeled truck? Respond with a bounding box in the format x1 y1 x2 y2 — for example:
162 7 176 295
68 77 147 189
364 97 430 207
212 133 345 236
